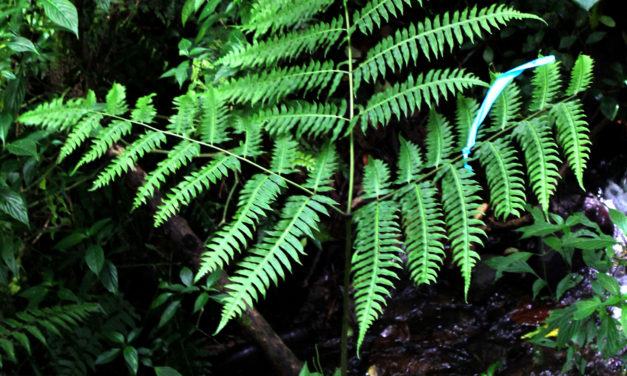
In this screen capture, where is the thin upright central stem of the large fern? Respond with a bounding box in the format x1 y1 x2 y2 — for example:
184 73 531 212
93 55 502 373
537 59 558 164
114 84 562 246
340 0 355 376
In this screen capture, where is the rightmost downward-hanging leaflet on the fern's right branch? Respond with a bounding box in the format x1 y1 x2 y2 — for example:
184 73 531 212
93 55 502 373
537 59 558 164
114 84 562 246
551 100 590 189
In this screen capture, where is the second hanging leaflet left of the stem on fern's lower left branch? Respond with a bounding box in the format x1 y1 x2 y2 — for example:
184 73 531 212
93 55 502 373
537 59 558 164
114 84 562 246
196 174 285 280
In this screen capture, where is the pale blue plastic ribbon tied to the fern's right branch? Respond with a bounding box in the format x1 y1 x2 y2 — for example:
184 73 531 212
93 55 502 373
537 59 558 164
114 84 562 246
462 55 555 171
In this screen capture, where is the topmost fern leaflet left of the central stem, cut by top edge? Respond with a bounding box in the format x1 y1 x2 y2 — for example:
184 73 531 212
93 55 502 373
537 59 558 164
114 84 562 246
241 0 333 38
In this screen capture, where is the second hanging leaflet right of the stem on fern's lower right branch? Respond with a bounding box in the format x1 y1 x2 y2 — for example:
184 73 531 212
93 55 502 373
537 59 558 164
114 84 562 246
401 181 446 286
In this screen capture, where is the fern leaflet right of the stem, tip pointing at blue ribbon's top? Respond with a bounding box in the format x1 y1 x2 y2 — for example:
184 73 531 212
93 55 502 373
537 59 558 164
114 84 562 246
360 69 487 131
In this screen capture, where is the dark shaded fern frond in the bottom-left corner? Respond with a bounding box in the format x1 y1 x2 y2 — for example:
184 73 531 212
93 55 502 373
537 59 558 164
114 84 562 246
0 303 100 368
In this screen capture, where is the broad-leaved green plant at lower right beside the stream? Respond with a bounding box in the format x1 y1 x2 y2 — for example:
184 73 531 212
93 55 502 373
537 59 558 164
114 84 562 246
486 209 627 374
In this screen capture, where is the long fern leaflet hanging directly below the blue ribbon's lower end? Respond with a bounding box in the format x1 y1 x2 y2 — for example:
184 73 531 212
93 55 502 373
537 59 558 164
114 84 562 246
442 164 485 299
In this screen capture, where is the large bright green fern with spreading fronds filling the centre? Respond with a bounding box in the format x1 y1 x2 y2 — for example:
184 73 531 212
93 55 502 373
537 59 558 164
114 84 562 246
12 0 593 368
